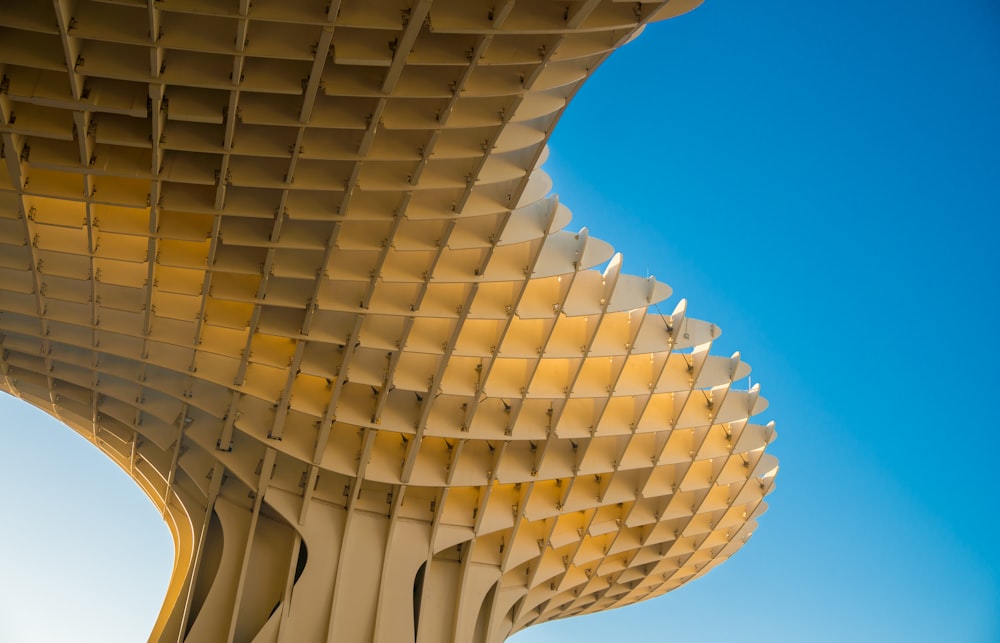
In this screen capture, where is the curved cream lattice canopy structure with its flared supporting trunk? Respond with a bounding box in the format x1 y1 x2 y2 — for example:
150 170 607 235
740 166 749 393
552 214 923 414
0 0 777 643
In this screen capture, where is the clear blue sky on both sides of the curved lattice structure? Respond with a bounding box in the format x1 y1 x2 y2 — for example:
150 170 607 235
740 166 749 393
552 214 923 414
0 0 1000 643
